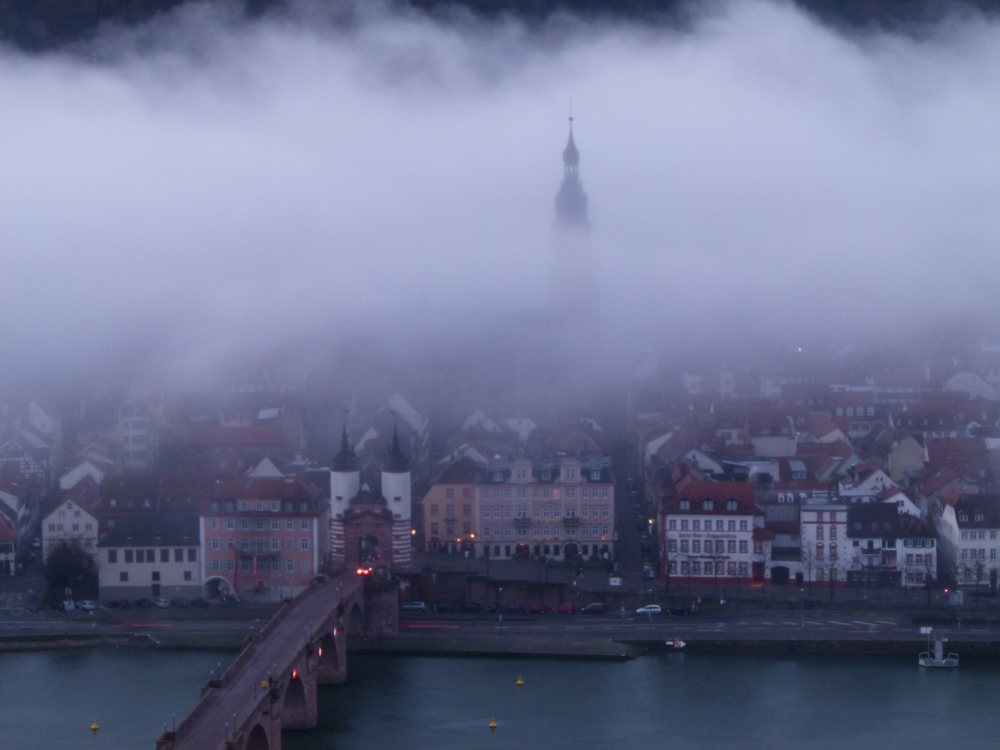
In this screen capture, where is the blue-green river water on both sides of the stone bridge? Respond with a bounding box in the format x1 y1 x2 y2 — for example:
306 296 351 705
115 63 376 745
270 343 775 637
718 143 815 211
0 650 1000 750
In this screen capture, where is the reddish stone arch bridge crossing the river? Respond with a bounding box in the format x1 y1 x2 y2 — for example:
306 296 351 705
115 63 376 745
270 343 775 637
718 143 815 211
156 573 399 750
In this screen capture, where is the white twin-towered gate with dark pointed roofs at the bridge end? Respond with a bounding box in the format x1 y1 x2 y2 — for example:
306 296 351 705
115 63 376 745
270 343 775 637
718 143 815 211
330 425 413 571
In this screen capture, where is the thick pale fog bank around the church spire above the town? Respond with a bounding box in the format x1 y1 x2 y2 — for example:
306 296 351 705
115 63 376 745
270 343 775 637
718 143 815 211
0 2 1000 384
